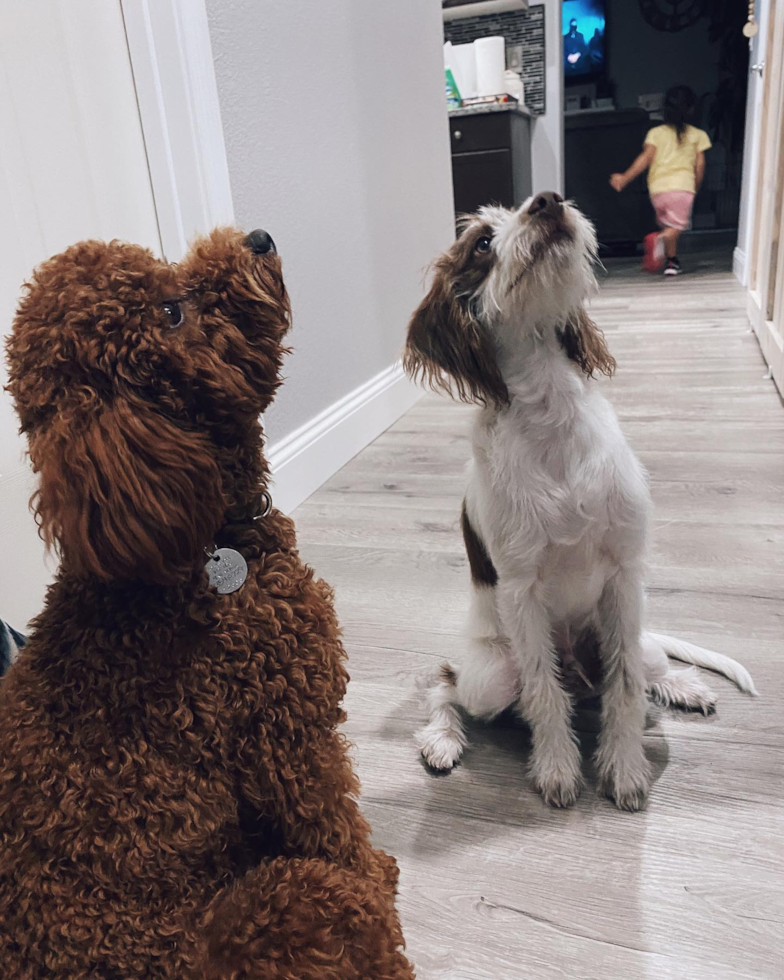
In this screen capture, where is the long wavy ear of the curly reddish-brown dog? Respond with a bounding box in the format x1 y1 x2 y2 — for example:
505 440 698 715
30 397 224 585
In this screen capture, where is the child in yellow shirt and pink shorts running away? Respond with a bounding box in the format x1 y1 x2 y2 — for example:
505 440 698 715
610 85 711 276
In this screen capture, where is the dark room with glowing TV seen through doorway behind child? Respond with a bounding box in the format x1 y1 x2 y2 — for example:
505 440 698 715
562 0 748 260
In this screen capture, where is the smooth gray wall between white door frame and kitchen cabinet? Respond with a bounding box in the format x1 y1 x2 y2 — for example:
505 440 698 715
207 0 453 442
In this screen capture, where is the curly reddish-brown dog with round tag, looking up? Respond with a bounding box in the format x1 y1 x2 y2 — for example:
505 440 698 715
0 229 413 980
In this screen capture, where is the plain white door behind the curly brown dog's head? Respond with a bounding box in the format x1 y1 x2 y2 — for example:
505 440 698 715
0 0 161 629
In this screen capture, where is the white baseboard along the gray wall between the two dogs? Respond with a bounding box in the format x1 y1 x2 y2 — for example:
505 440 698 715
267 363 423 514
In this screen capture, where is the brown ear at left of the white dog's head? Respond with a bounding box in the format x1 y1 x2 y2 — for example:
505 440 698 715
403 274 509 408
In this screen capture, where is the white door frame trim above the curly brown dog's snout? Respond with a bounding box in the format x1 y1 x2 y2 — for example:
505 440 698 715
120 0 234 262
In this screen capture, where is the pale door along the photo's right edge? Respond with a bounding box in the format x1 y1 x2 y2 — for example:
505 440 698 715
747 2 784 394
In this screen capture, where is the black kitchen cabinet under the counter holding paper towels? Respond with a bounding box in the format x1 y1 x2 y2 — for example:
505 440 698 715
449 109 531 214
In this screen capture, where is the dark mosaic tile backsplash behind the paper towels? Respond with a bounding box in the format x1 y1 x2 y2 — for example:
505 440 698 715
444 4 545 115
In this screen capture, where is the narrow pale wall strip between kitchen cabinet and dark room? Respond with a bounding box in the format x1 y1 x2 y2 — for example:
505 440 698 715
531 0 564 194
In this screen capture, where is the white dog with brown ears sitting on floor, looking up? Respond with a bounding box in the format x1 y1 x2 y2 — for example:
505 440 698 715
404 193 756 810
